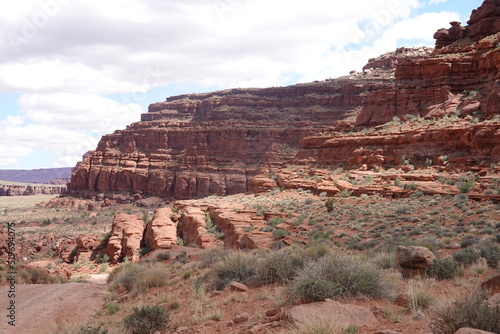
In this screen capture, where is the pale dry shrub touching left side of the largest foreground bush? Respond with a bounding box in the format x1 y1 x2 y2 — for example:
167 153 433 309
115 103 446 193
256 248 306 285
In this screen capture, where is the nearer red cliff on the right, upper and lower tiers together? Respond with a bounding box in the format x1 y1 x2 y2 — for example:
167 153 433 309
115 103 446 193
296 0 500 170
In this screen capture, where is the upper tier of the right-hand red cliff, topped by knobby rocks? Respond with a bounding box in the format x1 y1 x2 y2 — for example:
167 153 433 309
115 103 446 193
356 0 500 126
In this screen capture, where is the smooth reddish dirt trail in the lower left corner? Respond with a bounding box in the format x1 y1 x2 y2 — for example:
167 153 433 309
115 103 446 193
0 283 106 334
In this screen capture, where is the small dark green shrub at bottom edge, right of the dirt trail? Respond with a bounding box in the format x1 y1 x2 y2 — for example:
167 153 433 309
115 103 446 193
123 306 169 334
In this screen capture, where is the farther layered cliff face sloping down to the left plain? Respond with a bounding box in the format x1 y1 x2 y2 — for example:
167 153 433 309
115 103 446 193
69 74 392 199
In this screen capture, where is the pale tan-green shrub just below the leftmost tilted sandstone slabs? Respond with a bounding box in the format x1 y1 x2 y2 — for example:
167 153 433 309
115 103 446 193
108 262 171 292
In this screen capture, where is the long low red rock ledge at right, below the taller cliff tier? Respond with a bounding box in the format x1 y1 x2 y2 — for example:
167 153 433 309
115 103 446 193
296 122 500 168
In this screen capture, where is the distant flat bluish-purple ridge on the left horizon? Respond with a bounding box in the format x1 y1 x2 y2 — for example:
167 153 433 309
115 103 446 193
0 167 71 183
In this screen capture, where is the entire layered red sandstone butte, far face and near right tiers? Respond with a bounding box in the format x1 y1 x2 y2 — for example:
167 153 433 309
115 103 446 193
68 0 500 199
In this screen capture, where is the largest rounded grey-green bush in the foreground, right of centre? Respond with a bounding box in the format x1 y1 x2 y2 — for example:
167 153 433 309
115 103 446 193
290 252 391 302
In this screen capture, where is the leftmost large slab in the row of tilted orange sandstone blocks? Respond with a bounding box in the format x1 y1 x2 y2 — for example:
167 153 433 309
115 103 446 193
106 214 146 263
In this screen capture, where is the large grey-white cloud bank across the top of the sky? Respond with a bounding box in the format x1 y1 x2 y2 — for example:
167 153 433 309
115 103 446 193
0 0 424 94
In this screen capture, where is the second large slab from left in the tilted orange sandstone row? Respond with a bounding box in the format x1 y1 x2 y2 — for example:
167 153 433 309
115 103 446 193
144 207 177 251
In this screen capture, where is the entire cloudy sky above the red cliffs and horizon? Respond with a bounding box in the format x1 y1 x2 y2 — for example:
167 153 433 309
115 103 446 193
0 0 482 169
